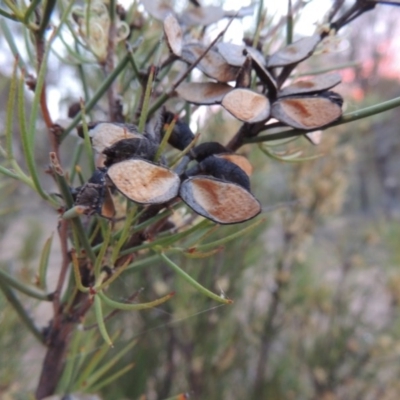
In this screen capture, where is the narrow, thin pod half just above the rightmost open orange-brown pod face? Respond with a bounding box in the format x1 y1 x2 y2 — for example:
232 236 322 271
278 74 342 97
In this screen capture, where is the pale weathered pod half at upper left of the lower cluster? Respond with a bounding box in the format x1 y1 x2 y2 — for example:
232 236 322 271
77 122 143 153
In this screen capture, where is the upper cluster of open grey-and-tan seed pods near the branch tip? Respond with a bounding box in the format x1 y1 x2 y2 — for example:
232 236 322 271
164 14 343 131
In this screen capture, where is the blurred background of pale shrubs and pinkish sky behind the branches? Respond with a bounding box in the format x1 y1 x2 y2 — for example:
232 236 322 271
0 1 400 400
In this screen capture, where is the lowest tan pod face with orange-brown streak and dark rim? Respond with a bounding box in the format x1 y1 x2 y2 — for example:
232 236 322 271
179 175 261 224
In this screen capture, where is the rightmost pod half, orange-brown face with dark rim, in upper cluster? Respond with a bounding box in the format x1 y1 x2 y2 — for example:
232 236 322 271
271 92 343 130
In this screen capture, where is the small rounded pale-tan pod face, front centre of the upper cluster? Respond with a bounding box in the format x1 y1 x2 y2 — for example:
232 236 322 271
221 89 270 123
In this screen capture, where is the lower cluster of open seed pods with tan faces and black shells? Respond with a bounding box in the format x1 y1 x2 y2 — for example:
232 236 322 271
72 119 261 224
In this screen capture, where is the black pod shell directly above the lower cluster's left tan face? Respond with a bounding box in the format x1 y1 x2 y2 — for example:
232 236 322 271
103 135 158 167
